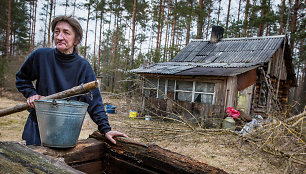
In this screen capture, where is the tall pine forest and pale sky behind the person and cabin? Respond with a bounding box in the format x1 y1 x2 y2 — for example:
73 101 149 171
0 0 306 109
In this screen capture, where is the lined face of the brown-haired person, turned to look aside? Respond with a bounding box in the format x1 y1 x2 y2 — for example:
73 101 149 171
53 21 76 54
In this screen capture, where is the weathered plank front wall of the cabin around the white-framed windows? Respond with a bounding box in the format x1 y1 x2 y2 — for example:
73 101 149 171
142 75 227 128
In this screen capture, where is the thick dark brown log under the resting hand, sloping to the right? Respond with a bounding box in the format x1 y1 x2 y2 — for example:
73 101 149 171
90 132 226 174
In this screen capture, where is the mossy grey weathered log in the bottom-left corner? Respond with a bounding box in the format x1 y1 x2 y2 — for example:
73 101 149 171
0 142 83 174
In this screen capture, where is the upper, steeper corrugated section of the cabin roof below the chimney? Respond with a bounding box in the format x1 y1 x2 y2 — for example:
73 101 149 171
172 36 285 63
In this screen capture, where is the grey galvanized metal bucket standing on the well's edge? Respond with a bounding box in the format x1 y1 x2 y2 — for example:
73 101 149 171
35 99 88 148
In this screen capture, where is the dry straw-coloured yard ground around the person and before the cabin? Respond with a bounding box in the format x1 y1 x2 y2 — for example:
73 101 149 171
0 94 305 174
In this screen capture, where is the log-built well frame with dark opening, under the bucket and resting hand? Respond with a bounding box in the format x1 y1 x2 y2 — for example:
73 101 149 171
30 132 226 174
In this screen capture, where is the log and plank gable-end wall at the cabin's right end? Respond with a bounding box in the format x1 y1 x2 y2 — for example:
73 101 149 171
251 48 290 117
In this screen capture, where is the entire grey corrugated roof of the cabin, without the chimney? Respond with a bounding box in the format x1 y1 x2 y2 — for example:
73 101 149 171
131 36 285 76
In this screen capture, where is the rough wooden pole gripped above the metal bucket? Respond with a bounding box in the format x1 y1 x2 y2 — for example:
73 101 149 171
0 81 98 117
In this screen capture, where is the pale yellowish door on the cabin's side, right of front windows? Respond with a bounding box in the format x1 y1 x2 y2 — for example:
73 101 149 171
237 85 254 115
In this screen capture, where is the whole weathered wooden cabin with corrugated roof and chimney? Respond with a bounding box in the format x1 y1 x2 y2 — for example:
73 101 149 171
132 26 296 127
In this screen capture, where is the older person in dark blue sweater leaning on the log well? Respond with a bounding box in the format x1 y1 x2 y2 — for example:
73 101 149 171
16 16 127 145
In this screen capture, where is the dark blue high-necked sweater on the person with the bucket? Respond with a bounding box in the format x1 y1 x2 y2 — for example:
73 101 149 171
16 48 111 145
